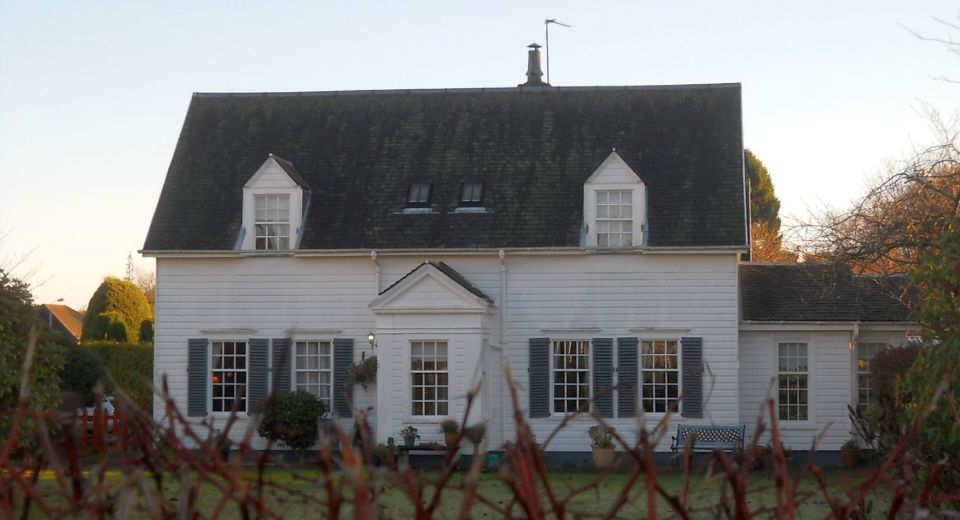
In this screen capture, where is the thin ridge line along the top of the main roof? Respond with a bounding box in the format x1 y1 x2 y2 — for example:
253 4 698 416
193 83 741 98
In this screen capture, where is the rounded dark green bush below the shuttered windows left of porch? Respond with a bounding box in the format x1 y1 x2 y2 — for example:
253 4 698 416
254 390 324 454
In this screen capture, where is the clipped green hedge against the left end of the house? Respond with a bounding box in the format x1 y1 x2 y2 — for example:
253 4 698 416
79 343 153 412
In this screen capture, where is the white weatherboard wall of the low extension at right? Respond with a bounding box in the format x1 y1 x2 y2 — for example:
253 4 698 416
740 332 903 451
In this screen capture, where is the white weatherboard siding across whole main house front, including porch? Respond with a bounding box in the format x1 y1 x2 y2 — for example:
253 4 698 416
155 252 741 452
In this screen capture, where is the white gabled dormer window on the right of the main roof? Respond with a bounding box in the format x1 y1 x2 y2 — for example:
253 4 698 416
581 151 647 249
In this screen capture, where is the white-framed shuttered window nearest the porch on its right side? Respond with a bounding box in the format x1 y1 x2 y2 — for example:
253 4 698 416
553 340 590 413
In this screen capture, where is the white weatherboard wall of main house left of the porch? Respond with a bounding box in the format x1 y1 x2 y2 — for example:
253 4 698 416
154 257 376 446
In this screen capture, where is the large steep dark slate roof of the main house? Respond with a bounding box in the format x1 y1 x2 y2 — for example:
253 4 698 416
144 84 746 251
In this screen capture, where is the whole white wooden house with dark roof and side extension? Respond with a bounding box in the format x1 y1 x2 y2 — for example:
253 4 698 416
143 46 911 453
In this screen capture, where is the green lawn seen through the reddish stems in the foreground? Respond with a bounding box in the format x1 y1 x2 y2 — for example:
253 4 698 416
24 469 890 520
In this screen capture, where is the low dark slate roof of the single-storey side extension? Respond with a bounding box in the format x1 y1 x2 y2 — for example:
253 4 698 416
740 263 910 322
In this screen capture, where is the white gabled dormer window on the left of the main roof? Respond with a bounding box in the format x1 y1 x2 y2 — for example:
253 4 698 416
238 154 310 251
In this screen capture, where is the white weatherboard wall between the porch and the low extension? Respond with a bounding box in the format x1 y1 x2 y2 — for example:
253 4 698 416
507 254 739 452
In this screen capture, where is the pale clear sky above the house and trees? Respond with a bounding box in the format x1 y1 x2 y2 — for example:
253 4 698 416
0 0 960 308
